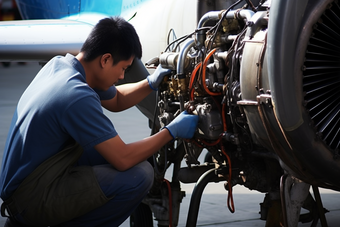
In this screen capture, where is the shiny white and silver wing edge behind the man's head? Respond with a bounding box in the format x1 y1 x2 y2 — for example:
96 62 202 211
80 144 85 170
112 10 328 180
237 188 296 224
0 19 93 61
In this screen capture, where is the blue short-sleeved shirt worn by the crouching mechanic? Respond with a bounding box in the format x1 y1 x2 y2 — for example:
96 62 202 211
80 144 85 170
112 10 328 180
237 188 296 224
0 54 117 200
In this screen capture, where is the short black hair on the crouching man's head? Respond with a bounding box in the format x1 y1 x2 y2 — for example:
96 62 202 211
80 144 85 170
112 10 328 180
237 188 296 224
81 17 142 64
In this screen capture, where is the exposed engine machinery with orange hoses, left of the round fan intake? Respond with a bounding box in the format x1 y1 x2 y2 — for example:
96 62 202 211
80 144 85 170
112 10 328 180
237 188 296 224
153 0 282 200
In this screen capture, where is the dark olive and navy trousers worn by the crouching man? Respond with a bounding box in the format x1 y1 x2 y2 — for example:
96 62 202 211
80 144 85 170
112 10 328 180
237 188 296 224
2 145 154 227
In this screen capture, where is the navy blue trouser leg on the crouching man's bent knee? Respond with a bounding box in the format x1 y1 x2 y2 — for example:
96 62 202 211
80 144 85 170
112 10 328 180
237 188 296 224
61 146 154 227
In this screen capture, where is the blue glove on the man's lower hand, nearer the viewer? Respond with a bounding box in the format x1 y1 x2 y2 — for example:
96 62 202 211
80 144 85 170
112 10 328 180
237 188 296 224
165 111 198 139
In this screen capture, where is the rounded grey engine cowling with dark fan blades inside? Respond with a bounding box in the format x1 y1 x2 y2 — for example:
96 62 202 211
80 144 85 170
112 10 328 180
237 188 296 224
266 1 340 190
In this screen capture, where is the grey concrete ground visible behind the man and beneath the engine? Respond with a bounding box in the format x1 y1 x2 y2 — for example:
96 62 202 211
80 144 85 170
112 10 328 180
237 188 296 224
0 62 340 227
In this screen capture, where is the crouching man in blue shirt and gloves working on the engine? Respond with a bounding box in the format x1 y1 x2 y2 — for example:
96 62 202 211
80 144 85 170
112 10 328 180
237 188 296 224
0 17 198 227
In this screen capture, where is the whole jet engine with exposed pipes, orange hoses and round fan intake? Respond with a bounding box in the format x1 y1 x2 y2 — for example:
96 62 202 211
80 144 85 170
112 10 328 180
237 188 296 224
134 0 340 226
